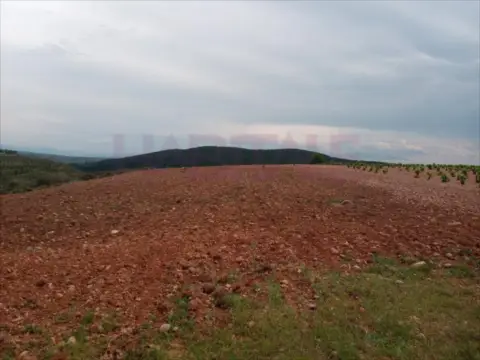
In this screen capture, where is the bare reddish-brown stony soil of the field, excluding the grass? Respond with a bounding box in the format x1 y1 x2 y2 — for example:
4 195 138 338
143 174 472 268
0 165 480 358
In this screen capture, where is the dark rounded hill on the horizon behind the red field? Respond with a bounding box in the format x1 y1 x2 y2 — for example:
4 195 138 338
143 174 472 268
75 146 350 171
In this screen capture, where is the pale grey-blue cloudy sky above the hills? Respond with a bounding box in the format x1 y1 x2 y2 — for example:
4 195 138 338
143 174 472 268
0 0 480 164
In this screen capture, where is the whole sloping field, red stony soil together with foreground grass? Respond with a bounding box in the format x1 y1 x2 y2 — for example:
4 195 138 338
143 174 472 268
0 165 480 359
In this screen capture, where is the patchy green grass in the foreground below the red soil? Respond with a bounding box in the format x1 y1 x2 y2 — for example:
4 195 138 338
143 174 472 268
12 256 480 360
